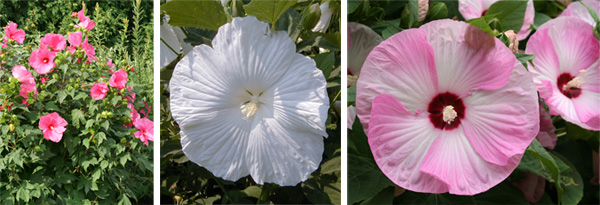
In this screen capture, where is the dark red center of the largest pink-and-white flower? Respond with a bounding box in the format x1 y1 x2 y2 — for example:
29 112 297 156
427 92 465 130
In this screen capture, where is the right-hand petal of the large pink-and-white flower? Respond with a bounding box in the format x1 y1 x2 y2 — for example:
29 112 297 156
461 62 540 166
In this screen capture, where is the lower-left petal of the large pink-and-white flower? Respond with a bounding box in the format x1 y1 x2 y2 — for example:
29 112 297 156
368 94 448 193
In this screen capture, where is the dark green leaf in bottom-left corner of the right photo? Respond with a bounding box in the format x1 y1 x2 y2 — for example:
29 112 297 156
347 153 394 204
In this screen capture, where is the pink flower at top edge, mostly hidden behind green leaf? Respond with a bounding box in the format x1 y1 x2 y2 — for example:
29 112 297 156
458 0 535 41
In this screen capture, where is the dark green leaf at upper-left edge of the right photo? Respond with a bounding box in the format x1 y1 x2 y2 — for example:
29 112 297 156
348 22 383 76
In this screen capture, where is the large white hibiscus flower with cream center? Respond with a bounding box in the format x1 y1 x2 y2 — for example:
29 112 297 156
170 16 329 186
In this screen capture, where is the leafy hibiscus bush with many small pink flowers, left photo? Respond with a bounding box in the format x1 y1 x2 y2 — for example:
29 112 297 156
0 9 153 204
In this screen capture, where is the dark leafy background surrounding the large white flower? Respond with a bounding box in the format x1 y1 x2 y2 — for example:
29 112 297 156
160 0 342 204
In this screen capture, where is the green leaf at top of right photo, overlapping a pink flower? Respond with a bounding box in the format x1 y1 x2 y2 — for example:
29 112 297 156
485 0 527 33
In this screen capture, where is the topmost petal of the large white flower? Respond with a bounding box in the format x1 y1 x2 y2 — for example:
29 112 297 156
212 16 300 94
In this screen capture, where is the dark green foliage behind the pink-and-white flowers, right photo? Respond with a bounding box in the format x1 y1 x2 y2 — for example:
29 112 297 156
347 0 600 204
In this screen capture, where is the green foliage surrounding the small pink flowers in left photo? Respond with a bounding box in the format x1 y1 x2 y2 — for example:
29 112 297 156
0 1 153 204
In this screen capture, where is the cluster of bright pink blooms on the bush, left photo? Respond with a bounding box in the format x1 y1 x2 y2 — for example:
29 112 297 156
2 9 153 145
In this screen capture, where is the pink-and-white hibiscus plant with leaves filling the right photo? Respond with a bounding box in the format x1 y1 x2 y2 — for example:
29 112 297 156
347 0 600 204
